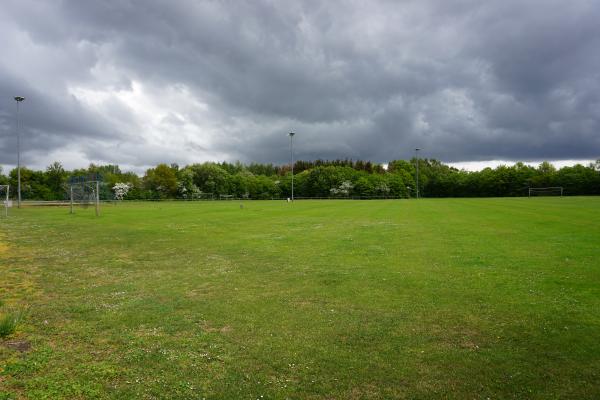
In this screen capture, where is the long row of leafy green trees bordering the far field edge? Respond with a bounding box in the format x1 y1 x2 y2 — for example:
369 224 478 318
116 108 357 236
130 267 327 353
0 158 600 200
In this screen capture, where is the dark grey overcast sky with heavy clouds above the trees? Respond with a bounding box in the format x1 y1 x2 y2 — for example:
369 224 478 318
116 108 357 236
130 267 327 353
0 0 600 171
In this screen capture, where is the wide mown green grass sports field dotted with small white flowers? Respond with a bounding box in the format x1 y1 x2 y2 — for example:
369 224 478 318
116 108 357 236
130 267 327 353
0 198 600 399
